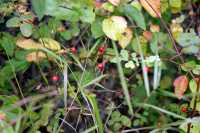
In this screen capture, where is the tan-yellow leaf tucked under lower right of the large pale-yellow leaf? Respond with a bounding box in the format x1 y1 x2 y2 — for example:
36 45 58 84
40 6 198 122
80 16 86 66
119 28 133 49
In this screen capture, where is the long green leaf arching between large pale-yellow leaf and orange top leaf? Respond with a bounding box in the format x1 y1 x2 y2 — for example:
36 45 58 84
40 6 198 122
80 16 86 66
124 5 146 30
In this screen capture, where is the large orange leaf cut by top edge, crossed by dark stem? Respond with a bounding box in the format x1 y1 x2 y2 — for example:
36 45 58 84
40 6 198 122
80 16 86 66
140 0 161 17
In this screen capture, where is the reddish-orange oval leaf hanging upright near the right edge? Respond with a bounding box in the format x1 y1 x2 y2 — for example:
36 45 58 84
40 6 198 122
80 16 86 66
174 75 188 99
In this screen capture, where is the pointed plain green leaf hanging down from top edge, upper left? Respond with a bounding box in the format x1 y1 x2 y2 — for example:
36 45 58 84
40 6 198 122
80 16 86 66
31 0 46 20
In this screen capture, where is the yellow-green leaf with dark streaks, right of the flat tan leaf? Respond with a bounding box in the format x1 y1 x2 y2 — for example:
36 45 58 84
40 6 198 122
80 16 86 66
39 38 61 50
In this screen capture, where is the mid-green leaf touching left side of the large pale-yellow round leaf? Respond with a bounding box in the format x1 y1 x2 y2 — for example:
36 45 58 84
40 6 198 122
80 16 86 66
91 19 104 38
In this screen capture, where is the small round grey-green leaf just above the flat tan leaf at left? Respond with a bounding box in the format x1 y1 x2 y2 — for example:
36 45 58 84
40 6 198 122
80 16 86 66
20 23 33 37
